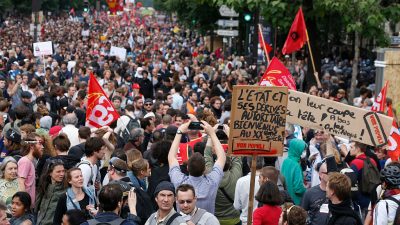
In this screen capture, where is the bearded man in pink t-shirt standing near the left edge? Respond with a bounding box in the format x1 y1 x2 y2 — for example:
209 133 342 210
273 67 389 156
18 133 43 205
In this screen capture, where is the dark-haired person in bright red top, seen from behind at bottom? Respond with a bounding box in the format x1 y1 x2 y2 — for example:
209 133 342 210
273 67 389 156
253 181 282 225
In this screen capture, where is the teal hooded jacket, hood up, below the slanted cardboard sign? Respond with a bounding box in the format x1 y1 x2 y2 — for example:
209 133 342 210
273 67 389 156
281 139 306 205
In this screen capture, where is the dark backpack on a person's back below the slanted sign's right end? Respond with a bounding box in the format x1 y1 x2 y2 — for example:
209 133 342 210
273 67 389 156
360 156 381 194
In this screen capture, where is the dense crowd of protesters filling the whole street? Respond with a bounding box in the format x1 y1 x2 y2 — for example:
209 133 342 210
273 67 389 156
0 6 400 225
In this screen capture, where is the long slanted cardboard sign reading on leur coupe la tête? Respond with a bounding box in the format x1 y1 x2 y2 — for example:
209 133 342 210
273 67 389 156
286 90 393 146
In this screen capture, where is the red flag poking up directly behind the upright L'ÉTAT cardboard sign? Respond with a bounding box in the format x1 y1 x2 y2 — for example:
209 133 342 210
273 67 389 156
259 57 296 90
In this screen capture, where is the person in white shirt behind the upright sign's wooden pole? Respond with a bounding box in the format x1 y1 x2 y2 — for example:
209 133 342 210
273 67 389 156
233 157 264 224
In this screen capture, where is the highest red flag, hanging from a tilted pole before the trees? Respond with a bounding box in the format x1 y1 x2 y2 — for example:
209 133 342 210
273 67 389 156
282 8 308 55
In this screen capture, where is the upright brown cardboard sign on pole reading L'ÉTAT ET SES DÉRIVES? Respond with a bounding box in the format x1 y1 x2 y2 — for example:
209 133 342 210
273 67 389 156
228 86 288 156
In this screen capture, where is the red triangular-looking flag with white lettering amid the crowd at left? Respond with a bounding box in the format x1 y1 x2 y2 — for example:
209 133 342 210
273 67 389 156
86 74 119 127
